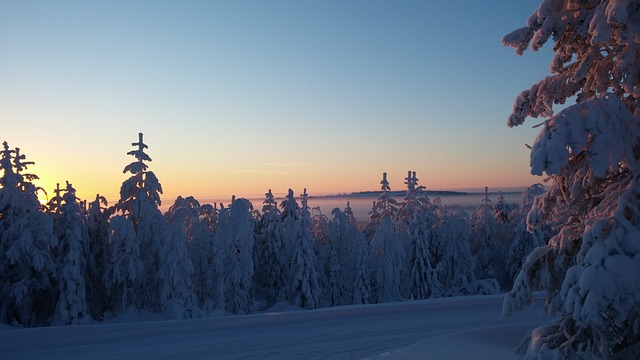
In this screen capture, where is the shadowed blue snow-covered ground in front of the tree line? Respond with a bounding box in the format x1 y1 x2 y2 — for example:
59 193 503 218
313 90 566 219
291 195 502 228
0 295 549 360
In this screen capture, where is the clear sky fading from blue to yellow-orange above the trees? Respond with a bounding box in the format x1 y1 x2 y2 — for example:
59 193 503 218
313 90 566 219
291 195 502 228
0 0 551 203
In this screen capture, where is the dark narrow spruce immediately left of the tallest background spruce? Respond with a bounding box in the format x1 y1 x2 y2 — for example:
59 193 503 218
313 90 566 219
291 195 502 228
86 195 113 319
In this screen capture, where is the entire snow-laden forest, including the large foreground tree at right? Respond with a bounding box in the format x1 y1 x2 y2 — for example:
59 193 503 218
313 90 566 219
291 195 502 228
0 0 640 359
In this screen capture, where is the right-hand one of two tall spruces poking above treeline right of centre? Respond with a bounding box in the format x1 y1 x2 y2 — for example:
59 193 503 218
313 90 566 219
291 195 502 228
398 171 443 299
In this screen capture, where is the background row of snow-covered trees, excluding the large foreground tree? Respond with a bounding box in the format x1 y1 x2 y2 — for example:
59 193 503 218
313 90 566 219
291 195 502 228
0 133 552 326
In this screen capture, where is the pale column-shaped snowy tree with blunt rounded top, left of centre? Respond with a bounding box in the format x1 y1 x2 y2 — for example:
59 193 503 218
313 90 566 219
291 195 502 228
218 198 255 314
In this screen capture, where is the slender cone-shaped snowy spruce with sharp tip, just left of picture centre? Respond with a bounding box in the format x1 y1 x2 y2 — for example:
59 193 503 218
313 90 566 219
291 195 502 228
289 189 320 309
